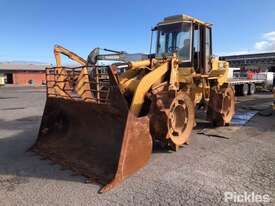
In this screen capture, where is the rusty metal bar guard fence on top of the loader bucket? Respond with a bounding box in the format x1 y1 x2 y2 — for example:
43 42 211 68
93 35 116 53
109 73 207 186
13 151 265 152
46 66 111 104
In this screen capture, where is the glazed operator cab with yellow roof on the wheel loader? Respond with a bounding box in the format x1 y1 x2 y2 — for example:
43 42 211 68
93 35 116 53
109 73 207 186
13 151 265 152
154 15 212 73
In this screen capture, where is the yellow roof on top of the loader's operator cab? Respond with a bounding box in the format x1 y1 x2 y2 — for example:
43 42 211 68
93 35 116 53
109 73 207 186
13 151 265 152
157 14 211 26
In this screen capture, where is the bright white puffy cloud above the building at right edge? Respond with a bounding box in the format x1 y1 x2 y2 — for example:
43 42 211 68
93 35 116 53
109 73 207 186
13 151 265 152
254 31 275 52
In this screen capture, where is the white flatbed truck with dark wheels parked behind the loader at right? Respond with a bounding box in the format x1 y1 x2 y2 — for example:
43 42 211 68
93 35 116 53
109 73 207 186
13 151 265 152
228 67 274 96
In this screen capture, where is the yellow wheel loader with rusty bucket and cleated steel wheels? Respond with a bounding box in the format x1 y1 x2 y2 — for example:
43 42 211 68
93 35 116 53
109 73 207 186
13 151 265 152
31 15 235 192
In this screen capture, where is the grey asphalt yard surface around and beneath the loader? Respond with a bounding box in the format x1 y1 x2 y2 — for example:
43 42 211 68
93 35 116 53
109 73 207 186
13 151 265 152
0 88 275 206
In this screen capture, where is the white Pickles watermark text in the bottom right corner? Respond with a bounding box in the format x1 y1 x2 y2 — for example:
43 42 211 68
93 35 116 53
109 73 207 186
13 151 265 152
224 192 271 203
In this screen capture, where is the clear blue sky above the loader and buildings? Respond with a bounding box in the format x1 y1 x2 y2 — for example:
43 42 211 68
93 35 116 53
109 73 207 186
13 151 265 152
0 0 275 63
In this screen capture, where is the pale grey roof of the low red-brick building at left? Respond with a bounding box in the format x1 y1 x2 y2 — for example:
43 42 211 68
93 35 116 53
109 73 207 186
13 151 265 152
0 63 50 71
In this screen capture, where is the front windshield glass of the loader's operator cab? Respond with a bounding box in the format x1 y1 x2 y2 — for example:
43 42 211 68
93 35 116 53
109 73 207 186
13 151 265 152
156 22 192 61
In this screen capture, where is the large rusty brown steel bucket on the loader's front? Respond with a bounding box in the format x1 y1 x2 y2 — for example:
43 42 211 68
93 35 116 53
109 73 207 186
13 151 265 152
31 65 155 192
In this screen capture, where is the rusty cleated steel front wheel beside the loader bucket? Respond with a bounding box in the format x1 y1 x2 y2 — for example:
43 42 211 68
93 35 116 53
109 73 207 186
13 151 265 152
150 87 195 151
